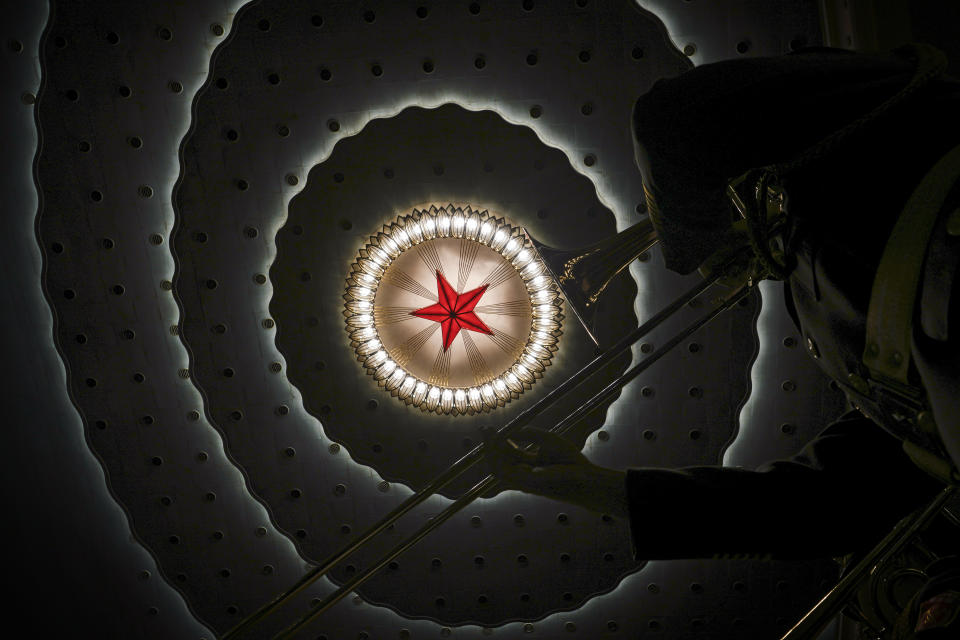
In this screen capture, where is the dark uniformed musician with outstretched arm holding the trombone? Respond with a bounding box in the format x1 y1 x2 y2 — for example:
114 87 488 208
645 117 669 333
488 45 960 637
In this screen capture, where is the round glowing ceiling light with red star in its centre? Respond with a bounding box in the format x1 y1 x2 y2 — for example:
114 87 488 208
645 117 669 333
344 204 563 415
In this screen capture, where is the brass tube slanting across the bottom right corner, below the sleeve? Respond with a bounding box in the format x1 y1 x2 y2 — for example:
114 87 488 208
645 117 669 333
780 486 956 640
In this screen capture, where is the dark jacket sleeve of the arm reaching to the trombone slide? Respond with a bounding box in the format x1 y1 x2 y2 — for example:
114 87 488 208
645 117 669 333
626 412 942 560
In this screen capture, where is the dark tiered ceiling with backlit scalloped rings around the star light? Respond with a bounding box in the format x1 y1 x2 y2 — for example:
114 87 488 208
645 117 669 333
4 0 840 640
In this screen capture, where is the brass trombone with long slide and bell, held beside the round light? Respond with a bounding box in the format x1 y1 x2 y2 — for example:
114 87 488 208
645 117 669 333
223 212 767 640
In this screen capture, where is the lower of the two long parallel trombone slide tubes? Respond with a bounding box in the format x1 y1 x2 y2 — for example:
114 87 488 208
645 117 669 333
274 278 753 640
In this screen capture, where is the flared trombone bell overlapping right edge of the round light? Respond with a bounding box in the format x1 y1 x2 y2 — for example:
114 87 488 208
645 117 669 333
524 219 657 344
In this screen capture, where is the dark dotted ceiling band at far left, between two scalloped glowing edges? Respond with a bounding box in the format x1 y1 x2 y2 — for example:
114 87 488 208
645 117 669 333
35 3 322 627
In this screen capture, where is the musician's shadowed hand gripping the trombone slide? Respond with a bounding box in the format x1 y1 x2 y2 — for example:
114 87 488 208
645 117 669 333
483 427 628 518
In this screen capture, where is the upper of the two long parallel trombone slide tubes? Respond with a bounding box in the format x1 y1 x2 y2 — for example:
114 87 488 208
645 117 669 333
223 248 724 640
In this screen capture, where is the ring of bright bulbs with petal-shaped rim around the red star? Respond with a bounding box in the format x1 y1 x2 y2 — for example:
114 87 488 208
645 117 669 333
344 205 563 415
